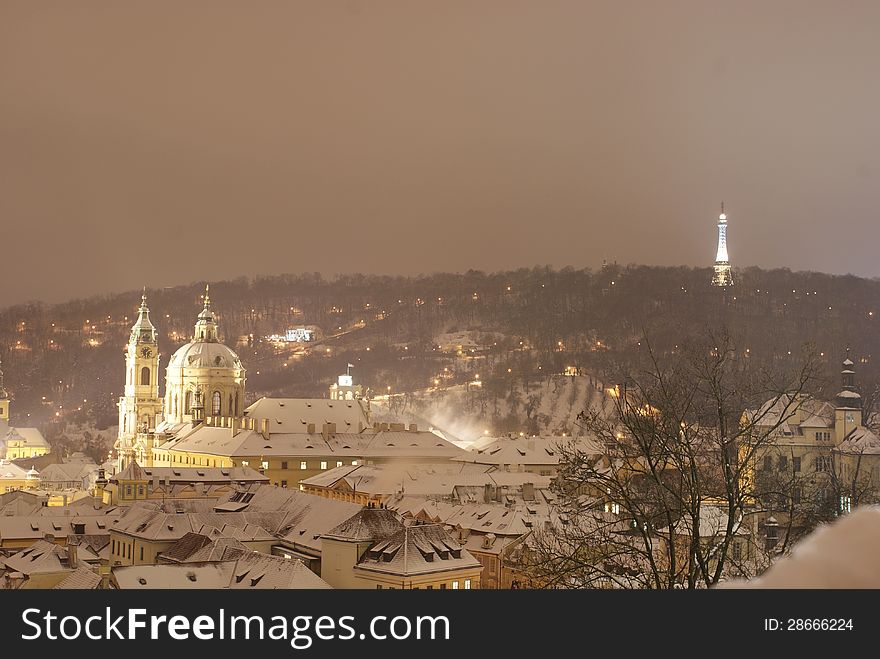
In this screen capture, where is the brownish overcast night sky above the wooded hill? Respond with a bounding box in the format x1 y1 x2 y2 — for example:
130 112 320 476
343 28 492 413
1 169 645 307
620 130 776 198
0 0 880 307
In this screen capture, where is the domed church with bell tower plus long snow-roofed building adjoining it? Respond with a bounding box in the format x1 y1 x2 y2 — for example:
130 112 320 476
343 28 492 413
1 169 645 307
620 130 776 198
115 287 465 492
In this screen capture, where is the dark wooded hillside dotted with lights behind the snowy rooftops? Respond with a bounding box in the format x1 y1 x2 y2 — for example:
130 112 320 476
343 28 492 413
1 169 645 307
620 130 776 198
0 265 880 444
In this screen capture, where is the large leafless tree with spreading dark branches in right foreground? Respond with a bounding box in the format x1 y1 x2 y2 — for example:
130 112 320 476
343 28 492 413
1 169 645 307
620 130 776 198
517 332 815 588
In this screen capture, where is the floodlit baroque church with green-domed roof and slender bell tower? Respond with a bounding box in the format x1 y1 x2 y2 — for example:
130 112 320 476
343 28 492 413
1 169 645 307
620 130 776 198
114 286 246 470
